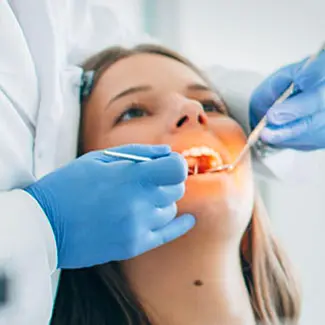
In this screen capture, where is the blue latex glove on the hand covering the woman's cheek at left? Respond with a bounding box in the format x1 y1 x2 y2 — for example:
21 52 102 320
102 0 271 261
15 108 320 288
26 145 195 268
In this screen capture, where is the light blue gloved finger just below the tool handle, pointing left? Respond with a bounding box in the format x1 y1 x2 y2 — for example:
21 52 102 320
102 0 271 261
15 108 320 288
266 83 325 125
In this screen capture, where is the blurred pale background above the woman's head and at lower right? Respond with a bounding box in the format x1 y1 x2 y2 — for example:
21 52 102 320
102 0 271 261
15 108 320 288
110 0 325 325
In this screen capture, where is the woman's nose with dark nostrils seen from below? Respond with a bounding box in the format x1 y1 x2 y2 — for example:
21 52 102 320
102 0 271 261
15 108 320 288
173 100 207 130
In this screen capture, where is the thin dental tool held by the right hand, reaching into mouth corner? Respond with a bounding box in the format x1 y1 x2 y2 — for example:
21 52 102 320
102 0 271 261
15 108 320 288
206 43 325 173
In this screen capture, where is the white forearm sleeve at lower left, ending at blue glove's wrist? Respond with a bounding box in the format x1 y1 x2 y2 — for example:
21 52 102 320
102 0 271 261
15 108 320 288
0 190 56 325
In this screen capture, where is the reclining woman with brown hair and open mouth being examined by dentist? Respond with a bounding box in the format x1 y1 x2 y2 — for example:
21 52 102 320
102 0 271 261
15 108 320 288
51 45 300 325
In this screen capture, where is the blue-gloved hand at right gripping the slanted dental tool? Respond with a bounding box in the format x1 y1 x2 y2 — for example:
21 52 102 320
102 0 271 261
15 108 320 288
250 52 325 151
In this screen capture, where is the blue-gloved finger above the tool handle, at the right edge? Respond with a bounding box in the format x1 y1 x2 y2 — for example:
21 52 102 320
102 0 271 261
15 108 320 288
295 51 325 91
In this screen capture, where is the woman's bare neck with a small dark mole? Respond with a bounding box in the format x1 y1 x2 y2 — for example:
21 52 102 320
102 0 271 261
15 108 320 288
124 228 254 325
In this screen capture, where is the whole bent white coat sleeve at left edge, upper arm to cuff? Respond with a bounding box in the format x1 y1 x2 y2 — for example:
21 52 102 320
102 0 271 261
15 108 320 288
0 1 57 325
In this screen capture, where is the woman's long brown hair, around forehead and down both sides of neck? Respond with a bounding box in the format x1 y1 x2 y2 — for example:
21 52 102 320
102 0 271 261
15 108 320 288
51 45 300 325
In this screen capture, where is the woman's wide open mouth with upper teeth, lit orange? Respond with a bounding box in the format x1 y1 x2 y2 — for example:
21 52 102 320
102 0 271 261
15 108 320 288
181 146 223 175
